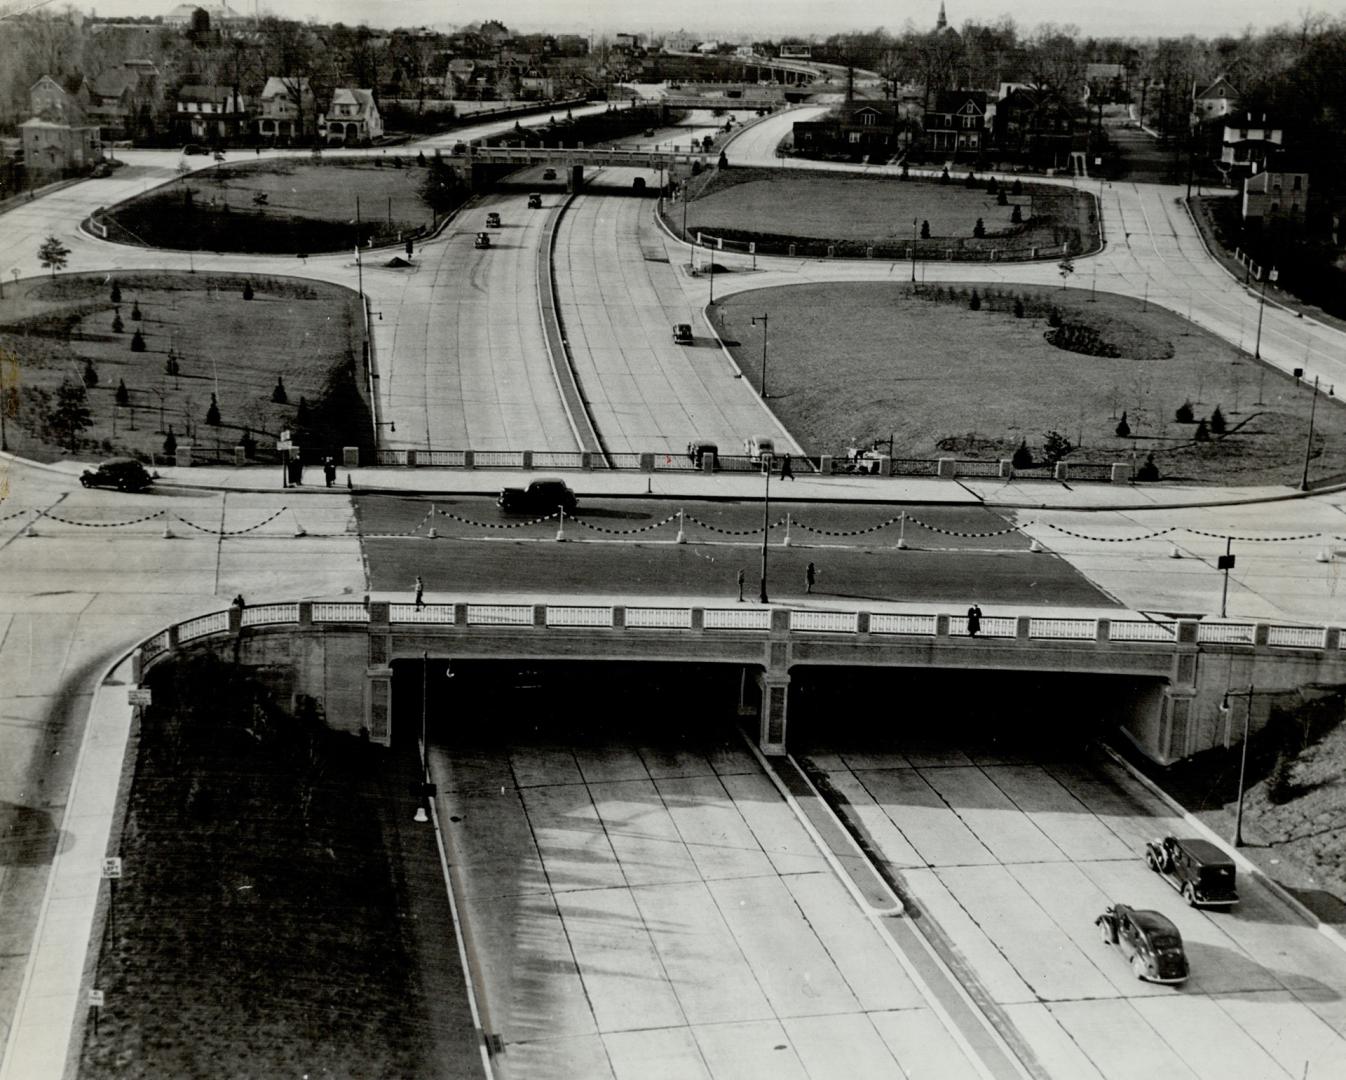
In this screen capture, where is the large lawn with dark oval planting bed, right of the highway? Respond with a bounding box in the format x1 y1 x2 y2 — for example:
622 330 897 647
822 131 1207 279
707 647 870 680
716 283 1346 483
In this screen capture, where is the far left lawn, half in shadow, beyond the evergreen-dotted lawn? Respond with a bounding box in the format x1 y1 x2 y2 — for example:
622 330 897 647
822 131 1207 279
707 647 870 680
100 152 446 255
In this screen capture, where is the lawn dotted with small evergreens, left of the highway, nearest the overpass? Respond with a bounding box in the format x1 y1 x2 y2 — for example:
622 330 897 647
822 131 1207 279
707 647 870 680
0 271 370 461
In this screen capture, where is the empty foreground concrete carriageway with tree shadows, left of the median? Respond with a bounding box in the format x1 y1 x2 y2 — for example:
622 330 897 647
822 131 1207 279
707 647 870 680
431 689 996 1080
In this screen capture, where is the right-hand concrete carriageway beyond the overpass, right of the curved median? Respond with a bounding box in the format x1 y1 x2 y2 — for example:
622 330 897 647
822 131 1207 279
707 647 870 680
556 170 798 454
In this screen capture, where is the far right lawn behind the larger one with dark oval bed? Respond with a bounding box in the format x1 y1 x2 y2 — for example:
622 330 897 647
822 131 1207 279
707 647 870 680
683 168 1096 259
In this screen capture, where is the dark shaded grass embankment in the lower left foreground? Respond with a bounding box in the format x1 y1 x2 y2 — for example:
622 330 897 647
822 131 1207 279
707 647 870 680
79 656 475 1080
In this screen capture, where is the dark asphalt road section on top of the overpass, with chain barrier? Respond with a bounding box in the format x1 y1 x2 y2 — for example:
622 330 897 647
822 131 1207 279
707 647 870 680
357 496 1113 615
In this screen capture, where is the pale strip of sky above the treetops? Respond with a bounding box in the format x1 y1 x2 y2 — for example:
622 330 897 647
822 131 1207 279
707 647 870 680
68 0 1346 38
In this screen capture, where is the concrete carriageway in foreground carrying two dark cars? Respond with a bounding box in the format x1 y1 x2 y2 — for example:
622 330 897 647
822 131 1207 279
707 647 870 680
795 694 1346 1080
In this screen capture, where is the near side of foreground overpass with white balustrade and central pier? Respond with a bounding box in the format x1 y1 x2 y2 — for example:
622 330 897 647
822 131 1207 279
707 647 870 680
133 597 1346 764
